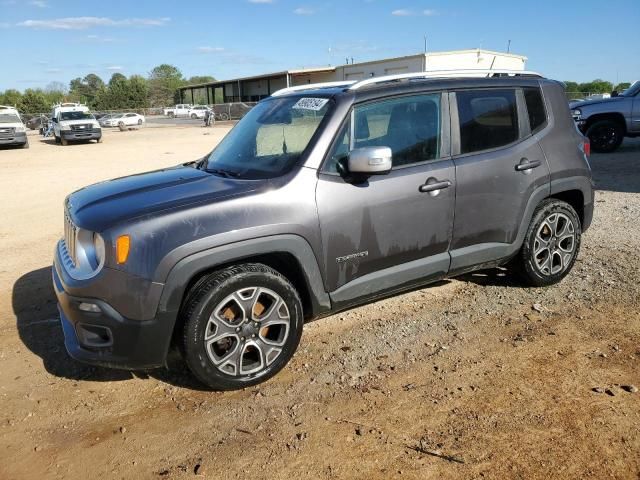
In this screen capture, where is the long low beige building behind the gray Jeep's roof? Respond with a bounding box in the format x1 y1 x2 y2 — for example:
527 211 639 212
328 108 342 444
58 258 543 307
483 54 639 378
180 49 527 105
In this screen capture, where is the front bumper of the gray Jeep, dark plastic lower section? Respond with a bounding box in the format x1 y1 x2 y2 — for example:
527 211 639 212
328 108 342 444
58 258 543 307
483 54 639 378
52 245 175 370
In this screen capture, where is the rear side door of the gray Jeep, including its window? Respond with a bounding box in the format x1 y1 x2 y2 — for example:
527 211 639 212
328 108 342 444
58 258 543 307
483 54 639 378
451 88 550 274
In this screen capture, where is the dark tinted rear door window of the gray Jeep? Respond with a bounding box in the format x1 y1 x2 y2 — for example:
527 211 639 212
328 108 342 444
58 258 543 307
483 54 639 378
456 89 519 153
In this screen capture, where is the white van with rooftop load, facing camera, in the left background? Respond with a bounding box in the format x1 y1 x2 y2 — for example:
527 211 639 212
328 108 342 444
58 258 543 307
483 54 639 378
51 103 102 145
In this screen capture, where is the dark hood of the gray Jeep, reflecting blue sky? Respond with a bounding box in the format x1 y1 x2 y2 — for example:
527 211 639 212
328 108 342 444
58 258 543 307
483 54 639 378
65 166 264 232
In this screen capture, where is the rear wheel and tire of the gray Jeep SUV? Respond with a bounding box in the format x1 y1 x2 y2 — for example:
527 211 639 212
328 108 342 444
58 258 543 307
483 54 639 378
515 198 582 287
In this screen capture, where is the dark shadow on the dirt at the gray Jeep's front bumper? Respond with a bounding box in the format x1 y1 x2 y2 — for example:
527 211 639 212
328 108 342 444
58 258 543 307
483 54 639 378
12 267 206 390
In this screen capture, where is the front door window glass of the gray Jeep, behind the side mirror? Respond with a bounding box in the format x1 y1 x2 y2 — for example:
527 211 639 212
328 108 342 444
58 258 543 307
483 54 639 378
352 93 440 167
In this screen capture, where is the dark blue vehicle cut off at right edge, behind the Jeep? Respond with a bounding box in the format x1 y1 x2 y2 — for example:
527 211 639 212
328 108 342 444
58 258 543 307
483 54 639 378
570 81 640 152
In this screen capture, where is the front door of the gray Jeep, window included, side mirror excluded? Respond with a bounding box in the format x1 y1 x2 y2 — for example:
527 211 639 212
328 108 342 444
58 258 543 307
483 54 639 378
316 93 455 305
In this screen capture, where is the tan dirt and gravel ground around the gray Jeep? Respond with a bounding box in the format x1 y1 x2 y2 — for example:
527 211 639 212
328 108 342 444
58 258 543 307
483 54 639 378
0 126 640 480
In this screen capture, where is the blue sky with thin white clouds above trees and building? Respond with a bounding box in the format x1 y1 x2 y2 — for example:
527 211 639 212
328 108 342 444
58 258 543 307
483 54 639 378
0 0 640 90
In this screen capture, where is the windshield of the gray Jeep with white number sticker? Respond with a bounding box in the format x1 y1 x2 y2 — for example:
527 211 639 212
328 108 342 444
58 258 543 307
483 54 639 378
203 97 333 179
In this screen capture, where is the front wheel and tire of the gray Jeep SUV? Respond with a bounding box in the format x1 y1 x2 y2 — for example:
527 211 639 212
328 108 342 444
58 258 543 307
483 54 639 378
181 263 304 390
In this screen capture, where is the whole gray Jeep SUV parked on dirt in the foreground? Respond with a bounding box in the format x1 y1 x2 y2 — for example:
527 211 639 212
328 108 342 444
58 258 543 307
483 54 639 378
53 75 593 389
